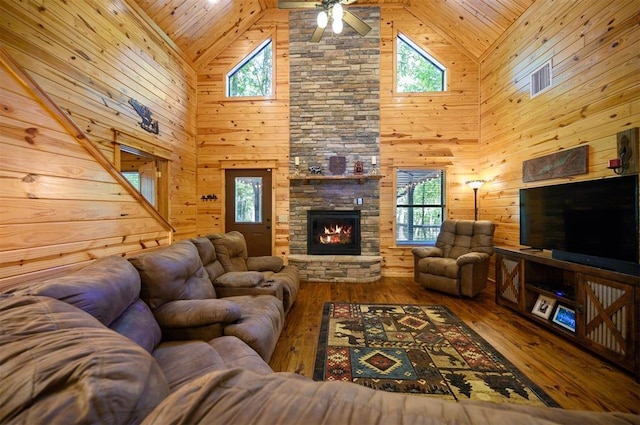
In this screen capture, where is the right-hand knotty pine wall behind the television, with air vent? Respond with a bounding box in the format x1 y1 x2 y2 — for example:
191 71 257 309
478 0 640 250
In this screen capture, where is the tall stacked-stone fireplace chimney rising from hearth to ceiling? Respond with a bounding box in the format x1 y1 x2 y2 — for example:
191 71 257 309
289 7 381 282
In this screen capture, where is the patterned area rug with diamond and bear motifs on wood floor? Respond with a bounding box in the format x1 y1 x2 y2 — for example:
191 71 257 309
313 303 559 407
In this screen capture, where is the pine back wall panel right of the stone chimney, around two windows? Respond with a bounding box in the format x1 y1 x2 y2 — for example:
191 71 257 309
380 7 479 276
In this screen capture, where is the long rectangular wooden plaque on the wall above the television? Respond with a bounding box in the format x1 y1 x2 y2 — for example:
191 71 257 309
522 146 589 183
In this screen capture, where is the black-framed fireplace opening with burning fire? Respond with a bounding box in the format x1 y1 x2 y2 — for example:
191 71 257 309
307 210 361 255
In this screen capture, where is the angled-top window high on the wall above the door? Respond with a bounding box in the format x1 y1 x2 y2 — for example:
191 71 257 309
227 39 273 97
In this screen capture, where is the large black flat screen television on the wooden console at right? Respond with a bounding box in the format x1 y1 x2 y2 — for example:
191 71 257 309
520 175 640 275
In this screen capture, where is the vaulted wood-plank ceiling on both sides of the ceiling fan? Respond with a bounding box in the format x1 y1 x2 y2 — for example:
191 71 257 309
134 0 535 69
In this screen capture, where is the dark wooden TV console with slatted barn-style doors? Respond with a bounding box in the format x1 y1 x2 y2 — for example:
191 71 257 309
495 247 640 381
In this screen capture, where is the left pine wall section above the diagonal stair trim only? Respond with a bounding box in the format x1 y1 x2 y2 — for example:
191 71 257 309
0 1 196 239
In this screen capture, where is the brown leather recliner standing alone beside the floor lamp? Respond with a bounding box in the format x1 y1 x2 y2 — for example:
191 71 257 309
411 220 496 297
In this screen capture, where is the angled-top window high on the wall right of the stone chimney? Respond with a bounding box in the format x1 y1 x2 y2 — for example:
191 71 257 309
396 34 446 93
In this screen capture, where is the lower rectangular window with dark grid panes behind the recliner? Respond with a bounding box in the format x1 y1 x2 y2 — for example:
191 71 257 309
396 169 445 245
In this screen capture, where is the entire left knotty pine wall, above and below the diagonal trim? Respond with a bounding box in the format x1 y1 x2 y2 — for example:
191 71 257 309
0 0 196 288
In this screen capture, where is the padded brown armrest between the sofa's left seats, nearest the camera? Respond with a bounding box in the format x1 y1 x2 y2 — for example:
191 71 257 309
153 299 242 328
